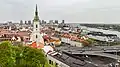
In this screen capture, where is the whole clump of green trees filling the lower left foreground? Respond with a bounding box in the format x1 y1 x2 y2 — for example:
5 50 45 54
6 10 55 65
0 41 48 67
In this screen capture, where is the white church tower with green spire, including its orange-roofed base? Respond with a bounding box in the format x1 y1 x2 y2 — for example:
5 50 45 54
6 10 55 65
31 5 44 48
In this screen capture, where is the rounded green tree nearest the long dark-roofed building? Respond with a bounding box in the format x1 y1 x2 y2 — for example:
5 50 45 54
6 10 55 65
19 47 46 67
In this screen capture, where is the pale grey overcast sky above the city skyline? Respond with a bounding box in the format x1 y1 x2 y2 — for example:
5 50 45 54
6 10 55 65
0 0 120 23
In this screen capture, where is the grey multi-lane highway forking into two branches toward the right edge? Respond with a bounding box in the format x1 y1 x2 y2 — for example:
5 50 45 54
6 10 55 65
56 44 120 60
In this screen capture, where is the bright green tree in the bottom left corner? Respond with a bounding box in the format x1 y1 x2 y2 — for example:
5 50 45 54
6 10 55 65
0 41 15 67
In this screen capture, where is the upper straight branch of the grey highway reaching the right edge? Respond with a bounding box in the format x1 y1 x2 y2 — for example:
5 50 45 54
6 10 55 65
62 46 120 53
